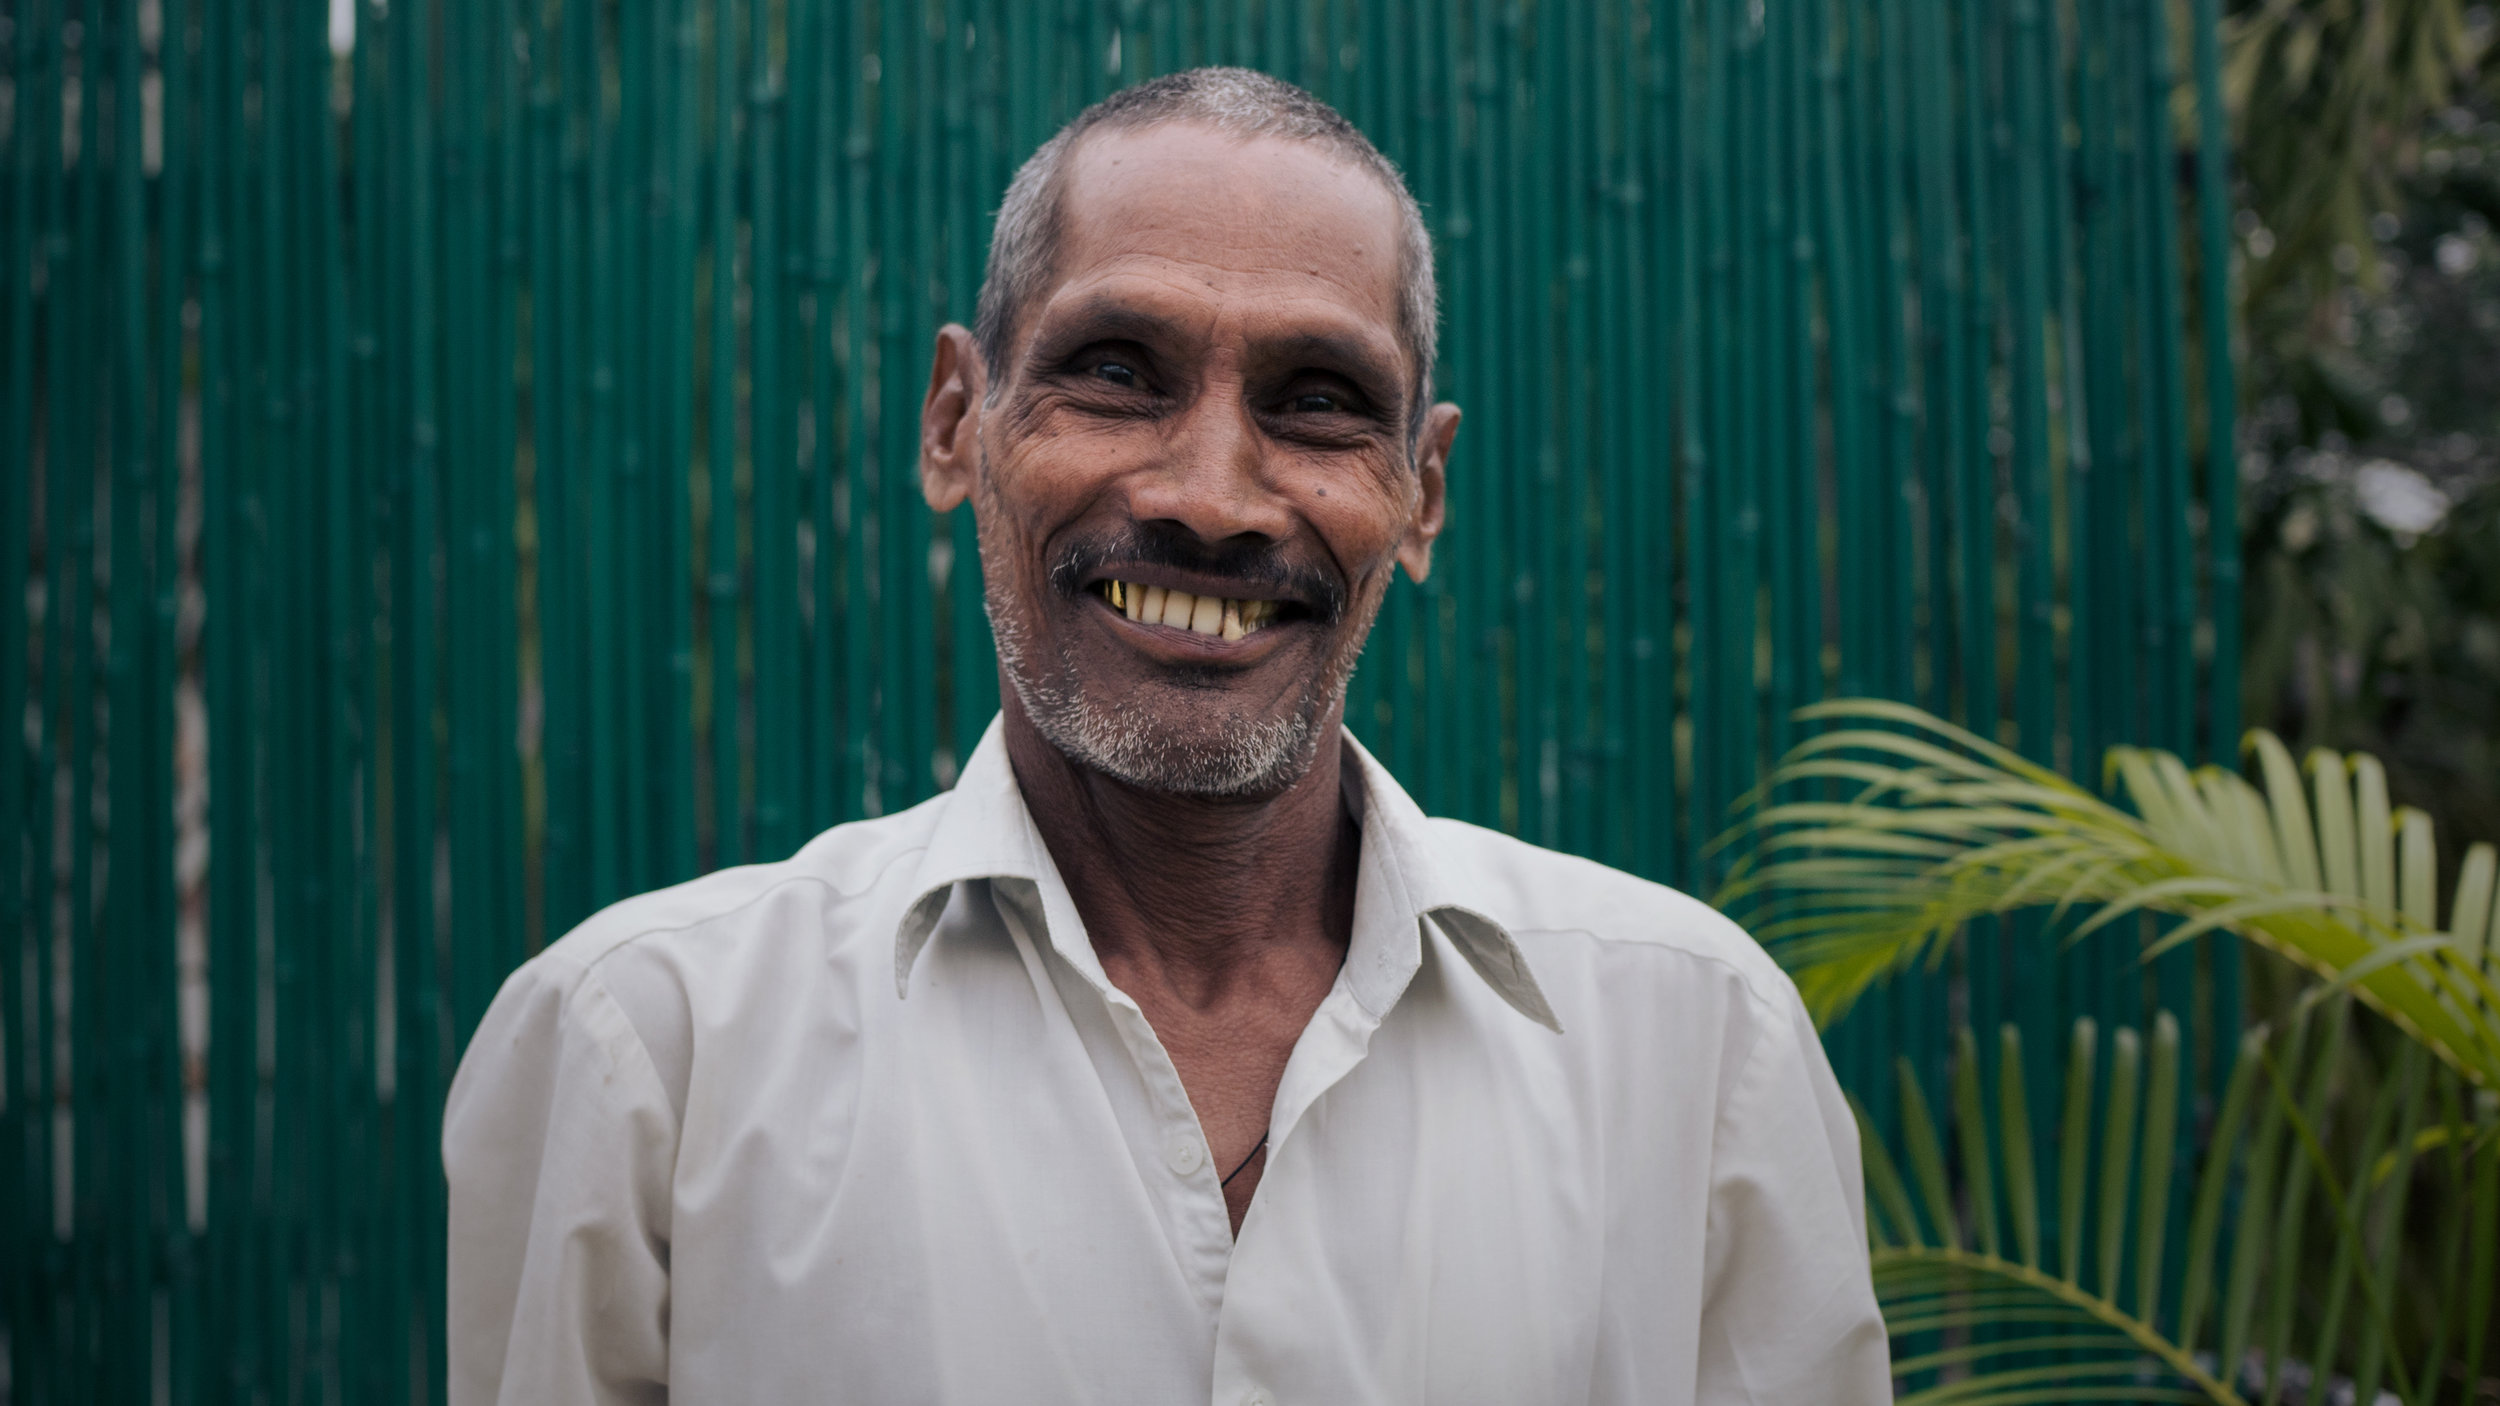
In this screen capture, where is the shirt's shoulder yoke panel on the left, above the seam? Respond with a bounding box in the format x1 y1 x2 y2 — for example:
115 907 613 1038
515 793 945 981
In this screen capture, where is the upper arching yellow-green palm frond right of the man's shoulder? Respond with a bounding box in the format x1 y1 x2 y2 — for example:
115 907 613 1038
1720 700 2500 1093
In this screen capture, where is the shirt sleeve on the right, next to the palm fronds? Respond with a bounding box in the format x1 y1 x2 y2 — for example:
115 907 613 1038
1695 991 1893 1406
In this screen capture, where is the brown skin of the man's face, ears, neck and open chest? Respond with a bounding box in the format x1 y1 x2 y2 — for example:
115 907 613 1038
920 123 1458 1233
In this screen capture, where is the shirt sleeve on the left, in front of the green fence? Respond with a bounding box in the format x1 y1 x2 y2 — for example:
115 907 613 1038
443 953 678 1406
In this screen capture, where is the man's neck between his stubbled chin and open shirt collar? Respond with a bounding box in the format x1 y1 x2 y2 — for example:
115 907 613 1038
1003 688 1363 1008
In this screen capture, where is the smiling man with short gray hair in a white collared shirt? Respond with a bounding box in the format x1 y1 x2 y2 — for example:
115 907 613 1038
443 70 1890 1406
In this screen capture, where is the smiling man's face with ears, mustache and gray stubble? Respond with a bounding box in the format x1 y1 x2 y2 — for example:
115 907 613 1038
923 125 1458 796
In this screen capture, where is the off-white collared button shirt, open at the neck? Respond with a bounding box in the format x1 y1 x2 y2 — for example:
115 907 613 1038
443 723 1890 1406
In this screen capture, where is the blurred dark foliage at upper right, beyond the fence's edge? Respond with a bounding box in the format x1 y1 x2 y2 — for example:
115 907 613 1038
2225 0 2500 863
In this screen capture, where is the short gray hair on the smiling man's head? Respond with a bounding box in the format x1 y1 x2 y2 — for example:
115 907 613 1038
973 68 1440 428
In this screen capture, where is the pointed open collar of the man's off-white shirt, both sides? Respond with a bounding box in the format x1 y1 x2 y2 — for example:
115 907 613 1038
895 718 1563 1033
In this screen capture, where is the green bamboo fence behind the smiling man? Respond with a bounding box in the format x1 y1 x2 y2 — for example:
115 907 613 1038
0 0 2238 1403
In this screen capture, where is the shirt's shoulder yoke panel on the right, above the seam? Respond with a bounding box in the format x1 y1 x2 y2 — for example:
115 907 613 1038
1428 818 1798 1008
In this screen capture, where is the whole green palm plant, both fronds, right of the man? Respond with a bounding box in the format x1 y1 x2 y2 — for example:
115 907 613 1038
1720 700 2500 1403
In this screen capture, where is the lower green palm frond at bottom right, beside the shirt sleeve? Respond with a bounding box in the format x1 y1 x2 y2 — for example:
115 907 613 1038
1860 998 2500 1406
